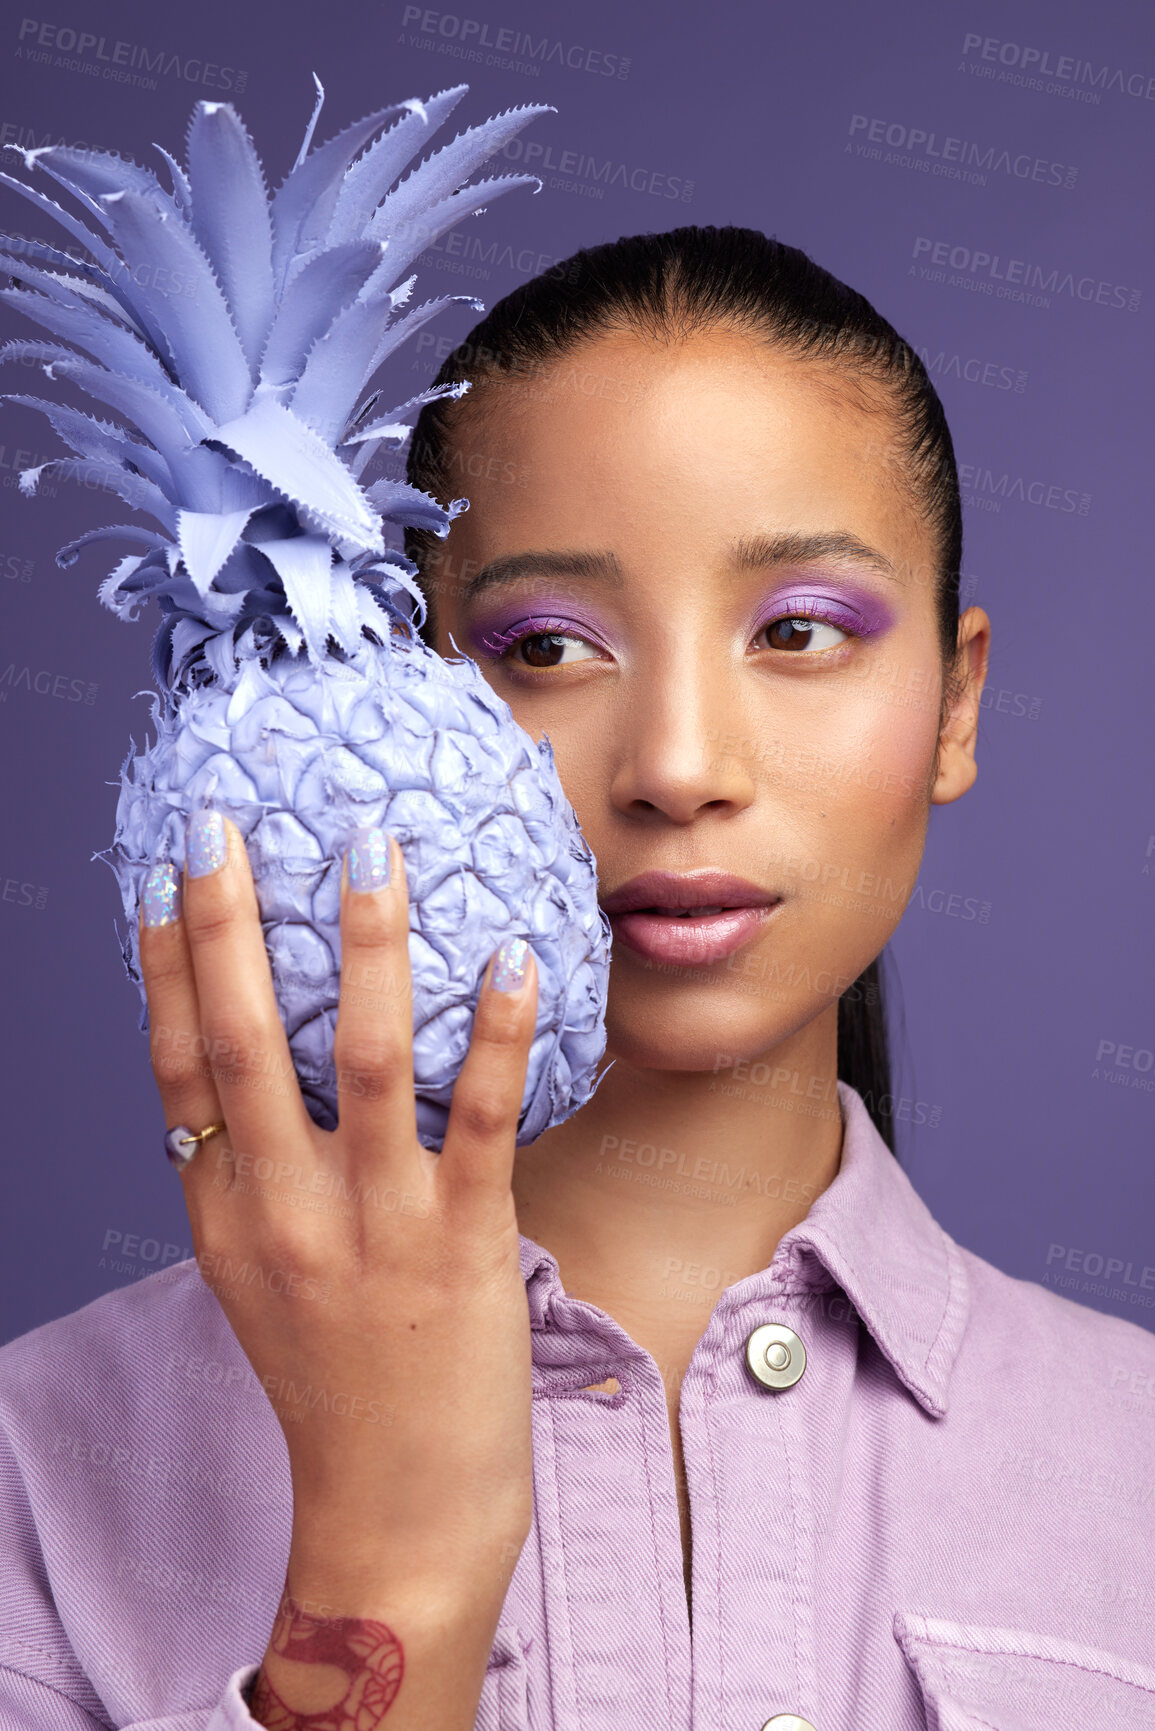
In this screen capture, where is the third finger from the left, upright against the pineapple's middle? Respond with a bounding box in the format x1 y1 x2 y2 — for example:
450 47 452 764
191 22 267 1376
332 829 417 1156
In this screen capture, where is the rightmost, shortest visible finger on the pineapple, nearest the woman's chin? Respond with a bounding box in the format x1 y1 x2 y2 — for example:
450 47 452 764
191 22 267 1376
438 938 537 1194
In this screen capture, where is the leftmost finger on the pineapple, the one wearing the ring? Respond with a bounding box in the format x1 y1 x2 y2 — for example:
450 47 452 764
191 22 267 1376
140 862 227 1238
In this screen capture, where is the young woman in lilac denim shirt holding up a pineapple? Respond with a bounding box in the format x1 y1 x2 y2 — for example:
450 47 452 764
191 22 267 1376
0 228 1155 1731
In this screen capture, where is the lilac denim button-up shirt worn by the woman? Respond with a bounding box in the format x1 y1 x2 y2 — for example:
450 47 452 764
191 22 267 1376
0 1085 1155 1731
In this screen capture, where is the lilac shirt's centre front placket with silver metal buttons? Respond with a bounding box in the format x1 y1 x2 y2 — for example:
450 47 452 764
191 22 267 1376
519 1243 857 1731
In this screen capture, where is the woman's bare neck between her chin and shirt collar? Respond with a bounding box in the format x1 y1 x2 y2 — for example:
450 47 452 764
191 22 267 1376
513 1006 842 1329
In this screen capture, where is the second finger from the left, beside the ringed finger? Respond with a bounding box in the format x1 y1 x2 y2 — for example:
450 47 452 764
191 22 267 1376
184 810 317 1168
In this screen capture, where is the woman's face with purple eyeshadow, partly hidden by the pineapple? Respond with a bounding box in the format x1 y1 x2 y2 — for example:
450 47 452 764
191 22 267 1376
426 329 987 1070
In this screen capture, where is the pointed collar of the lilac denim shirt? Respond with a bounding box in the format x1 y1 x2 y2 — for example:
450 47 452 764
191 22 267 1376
521 1082 970 1418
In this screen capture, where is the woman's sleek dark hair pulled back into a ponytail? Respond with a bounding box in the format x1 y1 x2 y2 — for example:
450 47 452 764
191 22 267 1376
405 227 963 1151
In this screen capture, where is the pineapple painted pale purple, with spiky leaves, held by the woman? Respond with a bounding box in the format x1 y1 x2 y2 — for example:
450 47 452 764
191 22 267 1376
0 85 610 1148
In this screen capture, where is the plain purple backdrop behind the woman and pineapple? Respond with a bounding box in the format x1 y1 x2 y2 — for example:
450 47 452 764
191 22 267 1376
0 0 1155 1338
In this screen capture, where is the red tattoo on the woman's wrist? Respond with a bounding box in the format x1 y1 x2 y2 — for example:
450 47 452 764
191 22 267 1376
249 1593 405 1731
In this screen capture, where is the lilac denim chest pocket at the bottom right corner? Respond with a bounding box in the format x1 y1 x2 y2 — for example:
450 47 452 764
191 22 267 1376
894 1612 1155 1731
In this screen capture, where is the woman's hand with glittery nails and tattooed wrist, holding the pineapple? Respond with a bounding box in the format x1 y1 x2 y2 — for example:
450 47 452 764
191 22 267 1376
140 812 537 1731
